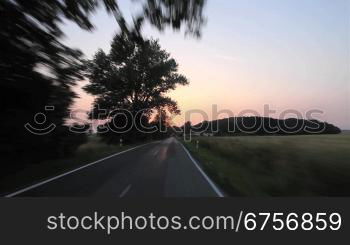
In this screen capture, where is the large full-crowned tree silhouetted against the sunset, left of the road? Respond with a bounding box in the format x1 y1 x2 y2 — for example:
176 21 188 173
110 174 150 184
85 33 188 141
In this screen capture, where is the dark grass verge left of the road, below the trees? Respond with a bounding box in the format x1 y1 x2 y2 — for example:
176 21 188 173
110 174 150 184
0 135 135 193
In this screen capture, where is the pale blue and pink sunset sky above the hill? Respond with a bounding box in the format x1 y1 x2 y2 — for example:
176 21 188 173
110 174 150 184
63 0 350 129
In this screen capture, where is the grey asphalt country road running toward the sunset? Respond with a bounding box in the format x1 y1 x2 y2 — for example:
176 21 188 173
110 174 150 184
7 138 223 197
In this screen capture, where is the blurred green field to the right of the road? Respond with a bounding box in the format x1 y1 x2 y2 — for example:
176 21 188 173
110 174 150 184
186 133 350 196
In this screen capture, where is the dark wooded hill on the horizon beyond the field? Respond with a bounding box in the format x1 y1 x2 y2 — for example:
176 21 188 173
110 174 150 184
181 117 341 136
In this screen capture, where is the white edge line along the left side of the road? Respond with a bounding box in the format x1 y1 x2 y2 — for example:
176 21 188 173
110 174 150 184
4 141 158 197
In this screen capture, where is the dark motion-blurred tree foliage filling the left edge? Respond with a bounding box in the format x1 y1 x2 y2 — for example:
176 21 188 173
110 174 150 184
0 0 91 171
